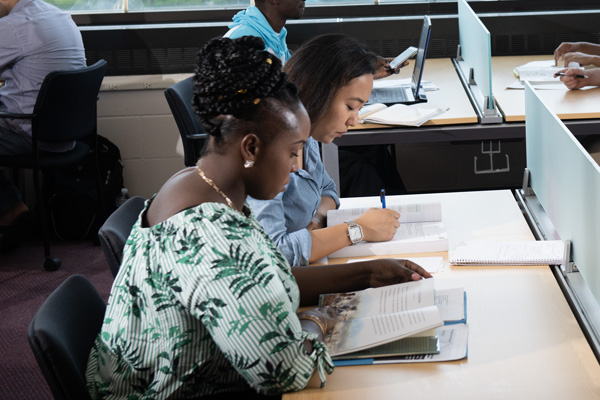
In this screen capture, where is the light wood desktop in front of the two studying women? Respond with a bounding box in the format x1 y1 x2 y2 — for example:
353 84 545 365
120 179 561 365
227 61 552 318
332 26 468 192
283 191 600 400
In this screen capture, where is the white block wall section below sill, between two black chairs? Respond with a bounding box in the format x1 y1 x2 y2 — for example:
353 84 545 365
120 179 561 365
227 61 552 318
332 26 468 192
98 74 189 197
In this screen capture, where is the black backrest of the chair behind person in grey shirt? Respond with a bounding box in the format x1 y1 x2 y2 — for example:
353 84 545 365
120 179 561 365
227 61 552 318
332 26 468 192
32 60 106 142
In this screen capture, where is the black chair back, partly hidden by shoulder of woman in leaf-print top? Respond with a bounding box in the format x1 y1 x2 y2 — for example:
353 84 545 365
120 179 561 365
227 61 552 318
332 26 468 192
98 196 146 276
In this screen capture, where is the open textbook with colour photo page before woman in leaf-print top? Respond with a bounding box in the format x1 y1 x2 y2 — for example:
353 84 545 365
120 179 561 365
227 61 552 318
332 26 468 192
319 279 444 358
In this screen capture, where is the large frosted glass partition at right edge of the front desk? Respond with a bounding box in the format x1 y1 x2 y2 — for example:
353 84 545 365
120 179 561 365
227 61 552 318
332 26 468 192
525 83 600 303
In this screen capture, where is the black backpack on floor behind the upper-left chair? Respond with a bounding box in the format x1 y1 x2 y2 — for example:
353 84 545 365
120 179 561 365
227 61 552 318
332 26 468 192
44 135 123 240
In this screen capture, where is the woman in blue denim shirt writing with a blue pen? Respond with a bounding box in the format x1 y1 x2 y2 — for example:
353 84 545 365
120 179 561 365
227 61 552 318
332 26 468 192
249 34 400 265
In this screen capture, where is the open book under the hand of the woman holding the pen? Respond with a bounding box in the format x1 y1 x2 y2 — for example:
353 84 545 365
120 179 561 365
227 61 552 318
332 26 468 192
327 203 448 258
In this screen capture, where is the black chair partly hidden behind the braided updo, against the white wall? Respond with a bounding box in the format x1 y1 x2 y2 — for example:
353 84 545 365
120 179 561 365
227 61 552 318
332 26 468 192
165 76 208 167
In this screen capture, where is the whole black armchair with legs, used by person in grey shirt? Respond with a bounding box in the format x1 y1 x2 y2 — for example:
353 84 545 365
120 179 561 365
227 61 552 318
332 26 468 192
0 60 106 271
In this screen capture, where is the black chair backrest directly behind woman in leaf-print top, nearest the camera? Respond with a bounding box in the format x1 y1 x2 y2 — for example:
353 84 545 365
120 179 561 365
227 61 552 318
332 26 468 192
27 275 106 400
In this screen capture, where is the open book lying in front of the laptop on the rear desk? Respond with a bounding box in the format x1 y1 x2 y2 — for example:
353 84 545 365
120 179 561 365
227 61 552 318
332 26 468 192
359 103 449 126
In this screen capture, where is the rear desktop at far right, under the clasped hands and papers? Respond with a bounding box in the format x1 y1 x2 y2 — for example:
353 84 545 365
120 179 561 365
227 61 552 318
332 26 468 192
492 55 600 122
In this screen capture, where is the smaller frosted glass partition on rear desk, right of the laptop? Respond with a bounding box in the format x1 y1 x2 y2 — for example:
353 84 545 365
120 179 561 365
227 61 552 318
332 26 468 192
458 0 494 110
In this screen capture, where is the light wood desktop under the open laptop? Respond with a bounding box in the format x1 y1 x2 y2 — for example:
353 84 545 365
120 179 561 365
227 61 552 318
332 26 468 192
355 58 477 129
